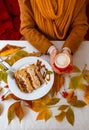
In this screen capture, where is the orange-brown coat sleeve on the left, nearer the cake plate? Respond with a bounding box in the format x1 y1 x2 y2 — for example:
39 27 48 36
18 0 52 54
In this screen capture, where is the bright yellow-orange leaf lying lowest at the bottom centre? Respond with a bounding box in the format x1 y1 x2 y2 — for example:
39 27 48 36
36 108 52 121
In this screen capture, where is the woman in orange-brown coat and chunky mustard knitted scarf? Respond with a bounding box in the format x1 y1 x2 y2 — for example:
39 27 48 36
18 0 88 74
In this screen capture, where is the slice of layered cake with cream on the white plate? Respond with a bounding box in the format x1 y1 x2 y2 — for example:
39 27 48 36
14 64 44 93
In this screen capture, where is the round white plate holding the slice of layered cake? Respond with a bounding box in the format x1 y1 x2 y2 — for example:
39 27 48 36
8 57 54 100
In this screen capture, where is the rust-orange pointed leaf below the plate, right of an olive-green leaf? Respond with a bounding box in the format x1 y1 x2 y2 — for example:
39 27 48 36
15 102 24 121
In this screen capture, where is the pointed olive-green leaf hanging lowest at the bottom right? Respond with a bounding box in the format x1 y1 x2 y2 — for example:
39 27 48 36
66 107 74 125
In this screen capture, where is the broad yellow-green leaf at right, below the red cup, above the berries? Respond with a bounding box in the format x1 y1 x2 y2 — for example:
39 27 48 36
69 74 83 89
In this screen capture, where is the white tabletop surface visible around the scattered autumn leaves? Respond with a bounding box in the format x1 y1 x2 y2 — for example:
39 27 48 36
0 40 89 130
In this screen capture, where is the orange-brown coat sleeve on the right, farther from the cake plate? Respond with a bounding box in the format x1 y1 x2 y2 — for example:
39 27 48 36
63 1 88 53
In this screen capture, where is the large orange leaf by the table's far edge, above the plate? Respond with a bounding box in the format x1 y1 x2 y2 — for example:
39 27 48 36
0 44 24 56
